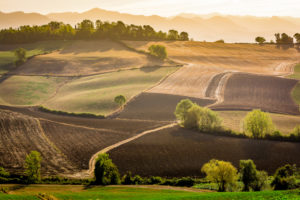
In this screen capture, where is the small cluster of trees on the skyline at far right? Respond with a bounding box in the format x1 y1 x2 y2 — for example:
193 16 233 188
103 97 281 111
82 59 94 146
255 33 300 45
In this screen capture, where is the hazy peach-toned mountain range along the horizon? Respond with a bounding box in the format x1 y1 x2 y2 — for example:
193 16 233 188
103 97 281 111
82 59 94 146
0 8 300 42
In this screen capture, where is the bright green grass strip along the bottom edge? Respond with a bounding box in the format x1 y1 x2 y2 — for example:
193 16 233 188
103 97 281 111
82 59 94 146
0 185 300 200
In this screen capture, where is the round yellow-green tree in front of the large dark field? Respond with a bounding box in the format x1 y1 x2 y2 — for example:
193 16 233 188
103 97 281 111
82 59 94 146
201 159 238 192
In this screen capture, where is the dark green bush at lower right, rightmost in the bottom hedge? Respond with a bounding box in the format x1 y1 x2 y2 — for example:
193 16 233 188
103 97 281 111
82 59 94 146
271 165 296 190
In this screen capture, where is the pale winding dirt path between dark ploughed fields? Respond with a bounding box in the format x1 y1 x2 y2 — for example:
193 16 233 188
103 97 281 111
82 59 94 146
68 123 177 178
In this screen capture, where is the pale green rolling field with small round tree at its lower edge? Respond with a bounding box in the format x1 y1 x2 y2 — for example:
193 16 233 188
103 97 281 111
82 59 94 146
44 67 177 115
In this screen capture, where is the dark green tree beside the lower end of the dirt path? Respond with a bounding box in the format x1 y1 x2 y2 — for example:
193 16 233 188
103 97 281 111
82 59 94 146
94 153 120 185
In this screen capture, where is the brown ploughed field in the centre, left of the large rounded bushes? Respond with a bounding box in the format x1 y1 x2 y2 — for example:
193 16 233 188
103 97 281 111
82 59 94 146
117 92 215 121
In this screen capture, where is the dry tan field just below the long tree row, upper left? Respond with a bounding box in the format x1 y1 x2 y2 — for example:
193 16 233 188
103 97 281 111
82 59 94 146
13 40 164 76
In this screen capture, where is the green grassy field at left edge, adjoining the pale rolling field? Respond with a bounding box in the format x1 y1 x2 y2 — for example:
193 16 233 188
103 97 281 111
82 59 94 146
0 76 65 105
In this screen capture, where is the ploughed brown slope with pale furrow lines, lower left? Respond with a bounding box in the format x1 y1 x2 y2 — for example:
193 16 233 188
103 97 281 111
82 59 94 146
0 110 77 174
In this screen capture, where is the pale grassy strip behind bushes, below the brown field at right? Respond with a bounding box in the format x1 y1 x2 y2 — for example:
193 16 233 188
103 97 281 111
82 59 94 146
218 111 300 134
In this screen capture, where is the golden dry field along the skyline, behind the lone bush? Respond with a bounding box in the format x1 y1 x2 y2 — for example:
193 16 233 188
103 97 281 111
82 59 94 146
122 41 300 75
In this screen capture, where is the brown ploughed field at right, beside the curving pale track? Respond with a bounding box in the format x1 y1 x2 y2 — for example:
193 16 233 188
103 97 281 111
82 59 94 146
212 74 300 115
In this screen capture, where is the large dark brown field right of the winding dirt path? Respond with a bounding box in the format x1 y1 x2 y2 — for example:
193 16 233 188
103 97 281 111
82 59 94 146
108 126 300 177
